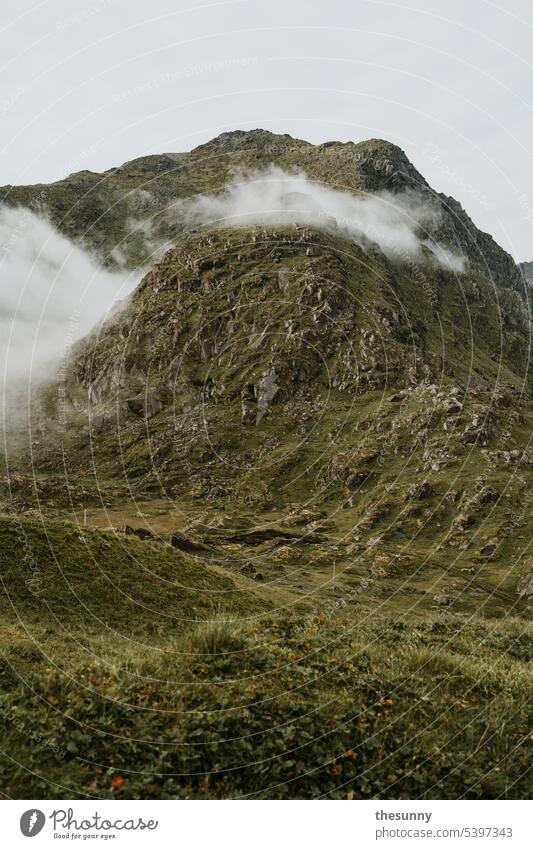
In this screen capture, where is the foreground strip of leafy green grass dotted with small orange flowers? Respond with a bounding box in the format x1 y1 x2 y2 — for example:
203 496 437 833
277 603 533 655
0 612 532 799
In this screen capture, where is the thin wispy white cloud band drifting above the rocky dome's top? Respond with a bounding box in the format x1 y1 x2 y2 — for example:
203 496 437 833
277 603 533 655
183 166 465 271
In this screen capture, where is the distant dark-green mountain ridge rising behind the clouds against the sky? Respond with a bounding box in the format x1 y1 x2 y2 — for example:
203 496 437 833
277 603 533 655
0 130 523 290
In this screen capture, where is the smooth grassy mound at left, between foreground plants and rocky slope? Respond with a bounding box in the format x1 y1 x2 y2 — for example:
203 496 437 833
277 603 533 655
0 516 270 628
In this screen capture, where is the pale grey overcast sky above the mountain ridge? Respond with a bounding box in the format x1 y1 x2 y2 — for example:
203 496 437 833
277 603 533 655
0 0 533 260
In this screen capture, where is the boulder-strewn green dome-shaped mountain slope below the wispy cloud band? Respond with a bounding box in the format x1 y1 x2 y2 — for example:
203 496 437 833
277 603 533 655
3 222 533 615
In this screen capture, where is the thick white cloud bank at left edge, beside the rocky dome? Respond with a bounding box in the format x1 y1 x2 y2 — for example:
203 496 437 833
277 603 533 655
0 206 139 406
